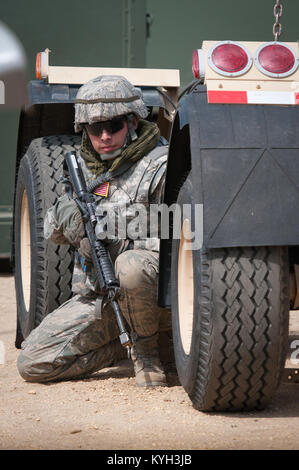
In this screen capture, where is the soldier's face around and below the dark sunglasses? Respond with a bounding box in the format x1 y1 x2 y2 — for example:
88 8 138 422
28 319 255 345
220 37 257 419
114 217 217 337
86 117 138 154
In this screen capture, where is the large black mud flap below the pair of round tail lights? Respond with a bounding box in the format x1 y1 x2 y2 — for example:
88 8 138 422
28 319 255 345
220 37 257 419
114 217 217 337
186 86 299 252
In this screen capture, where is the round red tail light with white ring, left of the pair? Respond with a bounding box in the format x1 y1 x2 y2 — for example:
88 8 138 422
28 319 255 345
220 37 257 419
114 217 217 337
208 41 252 77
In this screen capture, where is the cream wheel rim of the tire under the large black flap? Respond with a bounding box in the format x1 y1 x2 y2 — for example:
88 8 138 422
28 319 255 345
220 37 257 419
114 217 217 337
178 219 194 355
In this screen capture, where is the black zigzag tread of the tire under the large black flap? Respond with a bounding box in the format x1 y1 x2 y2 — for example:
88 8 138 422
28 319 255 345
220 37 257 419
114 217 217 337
190 247 289 411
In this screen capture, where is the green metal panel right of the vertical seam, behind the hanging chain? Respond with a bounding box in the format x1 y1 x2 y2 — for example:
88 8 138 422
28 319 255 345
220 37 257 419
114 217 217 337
146 0 299 86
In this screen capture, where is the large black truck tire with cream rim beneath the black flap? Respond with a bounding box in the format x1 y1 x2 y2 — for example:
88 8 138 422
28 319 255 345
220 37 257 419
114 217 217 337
171 178 289 411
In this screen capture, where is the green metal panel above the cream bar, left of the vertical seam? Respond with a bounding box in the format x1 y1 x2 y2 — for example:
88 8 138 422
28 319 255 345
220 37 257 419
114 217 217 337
0 0 145 74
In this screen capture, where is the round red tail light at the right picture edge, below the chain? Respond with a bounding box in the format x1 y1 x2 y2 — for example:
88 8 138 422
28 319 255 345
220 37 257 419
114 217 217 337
254 42 298 78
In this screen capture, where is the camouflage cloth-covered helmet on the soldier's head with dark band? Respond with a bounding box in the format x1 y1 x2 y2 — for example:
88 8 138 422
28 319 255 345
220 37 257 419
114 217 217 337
75 75 148 132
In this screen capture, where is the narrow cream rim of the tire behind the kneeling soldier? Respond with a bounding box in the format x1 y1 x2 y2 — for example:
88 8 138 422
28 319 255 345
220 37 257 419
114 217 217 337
20 190 31 311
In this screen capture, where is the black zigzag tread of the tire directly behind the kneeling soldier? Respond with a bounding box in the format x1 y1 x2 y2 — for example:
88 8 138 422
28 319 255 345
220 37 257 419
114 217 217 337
17 135 81 327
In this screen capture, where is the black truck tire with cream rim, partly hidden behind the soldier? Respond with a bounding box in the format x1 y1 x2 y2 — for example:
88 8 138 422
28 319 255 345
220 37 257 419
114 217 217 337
14 135 80 348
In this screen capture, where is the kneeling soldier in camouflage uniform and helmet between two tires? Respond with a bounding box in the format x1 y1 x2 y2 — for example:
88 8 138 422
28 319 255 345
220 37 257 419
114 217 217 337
18 76 171 386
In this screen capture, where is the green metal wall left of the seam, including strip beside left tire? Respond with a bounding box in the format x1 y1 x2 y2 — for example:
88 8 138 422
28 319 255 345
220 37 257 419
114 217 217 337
0 0 146 257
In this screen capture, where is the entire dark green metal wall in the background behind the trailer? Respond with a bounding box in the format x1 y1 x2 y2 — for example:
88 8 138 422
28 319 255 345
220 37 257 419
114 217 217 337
0 0 299 256
